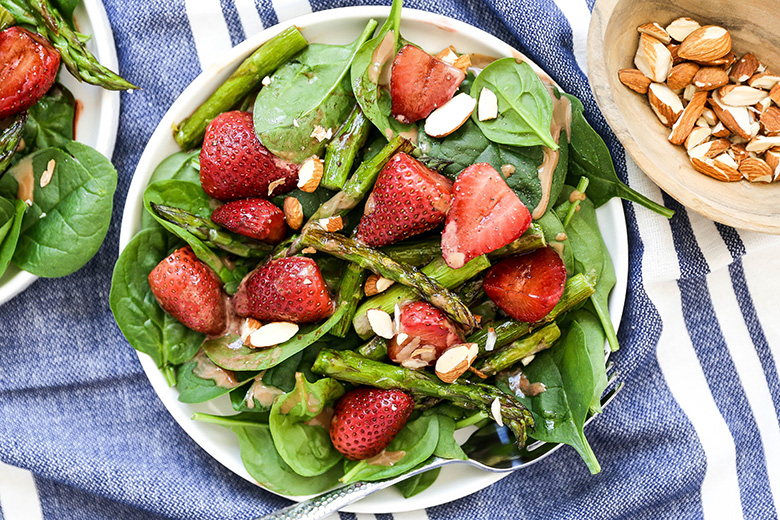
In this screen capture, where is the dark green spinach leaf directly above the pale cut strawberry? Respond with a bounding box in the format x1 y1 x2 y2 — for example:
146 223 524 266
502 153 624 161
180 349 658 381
419 119 544 208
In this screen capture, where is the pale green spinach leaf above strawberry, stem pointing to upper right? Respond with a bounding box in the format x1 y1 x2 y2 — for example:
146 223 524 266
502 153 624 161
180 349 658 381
254 20 376 163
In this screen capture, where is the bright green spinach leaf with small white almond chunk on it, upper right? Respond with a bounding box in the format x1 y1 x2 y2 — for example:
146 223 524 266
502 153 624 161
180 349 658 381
471 58 558 150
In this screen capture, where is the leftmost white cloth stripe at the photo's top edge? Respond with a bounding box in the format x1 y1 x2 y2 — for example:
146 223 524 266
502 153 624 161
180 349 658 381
184 0 233 70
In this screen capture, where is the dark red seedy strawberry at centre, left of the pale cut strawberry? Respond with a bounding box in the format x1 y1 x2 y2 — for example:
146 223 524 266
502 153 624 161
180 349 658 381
357 153 452 247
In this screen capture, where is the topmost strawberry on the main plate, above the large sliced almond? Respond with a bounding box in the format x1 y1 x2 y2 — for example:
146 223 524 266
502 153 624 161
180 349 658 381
390 45 466 123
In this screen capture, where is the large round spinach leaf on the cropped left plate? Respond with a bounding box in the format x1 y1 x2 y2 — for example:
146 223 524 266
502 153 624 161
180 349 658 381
0 141 117 278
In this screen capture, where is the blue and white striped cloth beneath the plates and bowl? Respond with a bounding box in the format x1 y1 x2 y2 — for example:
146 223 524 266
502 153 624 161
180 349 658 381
0 0 780 520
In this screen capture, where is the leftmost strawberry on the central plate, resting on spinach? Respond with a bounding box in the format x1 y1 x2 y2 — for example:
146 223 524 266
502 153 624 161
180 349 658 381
149 246 227 336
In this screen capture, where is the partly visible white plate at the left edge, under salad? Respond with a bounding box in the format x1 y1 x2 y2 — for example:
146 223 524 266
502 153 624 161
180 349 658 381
0 0 119 305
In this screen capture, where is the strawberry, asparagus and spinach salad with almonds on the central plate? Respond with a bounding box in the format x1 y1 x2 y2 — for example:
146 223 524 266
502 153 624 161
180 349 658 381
110 1 666 497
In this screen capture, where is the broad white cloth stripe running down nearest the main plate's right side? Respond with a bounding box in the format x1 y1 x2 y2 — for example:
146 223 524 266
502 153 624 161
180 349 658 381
626 159 743 519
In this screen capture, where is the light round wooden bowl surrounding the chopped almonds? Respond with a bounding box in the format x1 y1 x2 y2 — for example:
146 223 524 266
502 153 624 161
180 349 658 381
588 0 780 234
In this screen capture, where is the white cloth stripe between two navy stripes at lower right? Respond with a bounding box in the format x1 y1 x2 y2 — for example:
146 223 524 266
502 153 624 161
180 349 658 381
707 268 780 510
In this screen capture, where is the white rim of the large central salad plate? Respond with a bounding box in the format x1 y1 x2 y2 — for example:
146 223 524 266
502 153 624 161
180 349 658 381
119 6 628 513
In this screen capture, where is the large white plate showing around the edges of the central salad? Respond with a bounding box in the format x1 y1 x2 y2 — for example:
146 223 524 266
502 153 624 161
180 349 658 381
119 7 628 513
